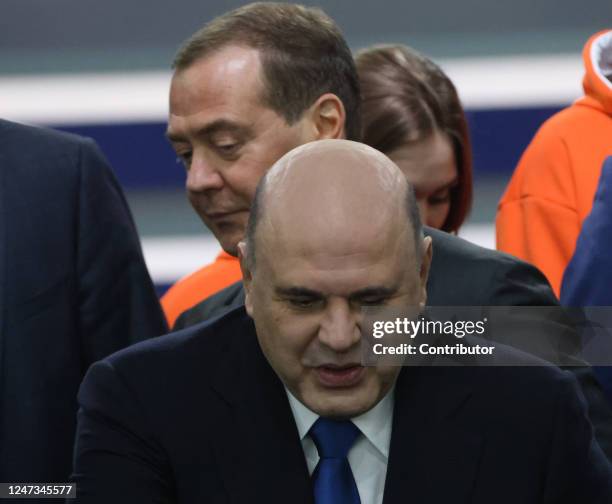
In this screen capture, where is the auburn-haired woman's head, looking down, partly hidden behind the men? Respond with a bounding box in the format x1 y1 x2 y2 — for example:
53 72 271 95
355 45 472 233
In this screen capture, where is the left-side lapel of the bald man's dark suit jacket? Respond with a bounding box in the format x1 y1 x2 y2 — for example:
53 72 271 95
215 315 312 504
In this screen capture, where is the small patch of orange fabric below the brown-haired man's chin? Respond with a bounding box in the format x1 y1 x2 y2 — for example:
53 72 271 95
161 251 242 327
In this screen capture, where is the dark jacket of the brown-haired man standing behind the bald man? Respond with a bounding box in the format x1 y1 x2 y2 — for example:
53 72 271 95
173 227 612 460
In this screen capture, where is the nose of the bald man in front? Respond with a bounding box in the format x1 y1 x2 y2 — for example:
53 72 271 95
319 299 361 352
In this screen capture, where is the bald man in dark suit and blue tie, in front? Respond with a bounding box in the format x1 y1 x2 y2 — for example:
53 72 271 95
75 140 612 504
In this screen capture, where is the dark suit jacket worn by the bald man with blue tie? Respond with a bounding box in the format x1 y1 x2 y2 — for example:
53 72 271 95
74 308 612 504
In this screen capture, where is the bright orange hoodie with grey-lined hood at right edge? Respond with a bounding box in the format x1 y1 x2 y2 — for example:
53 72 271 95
496 31 612 296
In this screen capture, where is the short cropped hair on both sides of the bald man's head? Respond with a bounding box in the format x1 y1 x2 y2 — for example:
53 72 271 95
244 173 424 271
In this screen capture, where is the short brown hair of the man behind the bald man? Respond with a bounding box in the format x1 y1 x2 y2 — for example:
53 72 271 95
172 2 361 141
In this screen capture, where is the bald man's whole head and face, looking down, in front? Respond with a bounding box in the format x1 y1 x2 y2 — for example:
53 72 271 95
239 140 431 418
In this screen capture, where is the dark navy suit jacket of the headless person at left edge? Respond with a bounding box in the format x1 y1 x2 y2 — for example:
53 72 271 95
0 121 165 482
